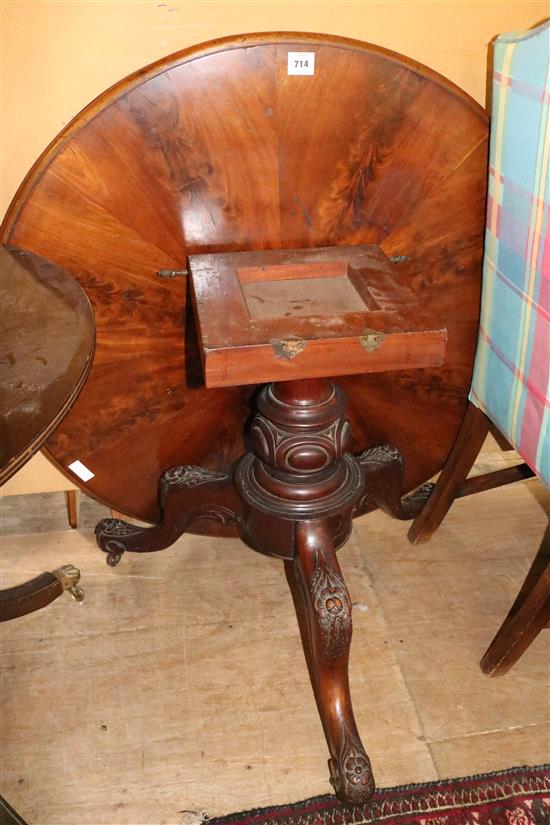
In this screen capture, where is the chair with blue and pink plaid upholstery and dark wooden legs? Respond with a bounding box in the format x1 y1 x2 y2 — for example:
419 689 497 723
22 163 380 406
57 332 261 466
409 22 550 675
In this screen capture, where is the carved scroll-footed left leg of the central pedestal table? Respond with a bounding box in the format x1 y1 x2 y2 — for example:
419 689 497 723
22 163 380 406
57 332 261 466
95 465 241 566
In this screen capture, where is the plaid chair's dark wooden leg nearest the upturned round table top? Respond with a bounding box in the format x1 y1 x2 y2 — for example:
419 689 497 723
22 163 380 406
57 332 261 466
408 403 490 544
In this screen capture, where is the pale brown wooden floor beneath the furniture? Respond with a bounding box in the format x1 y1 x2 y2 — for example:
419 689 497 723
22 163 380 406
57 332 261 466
0 448 550 825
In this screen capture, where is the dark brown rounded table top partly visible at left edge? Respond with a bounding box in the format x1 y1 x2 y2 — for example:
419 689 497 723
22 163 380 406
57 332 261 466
0 247 94 484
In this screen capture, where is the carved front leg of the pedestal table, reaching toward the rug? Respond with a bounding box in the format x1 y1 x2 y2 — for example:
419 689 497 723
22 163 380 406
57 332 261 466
285 522 374 804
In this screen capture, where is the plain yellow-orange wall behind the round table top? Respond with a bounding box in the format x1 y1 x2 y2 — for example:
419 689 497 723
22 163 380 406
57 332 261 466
0 0 548 214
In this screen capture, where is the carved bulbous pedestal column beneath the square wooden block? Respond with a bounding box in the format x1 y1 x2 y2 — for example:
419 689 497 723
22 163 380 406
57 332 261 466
235 379 363 560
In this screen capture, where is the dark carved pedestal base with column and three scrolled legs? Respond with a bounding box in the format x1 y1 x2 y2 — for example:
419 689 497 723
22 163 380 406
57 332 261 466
96 379 430 803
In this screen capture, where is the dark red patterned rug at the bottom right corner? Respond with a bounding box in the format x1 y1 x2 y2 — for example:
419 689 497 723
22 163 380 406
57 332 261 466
207 765 550 825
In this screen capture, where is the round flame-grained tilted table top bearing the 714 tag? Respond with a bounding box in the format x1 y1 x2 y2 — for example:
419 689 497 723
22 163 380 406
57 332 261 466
1 33 487 530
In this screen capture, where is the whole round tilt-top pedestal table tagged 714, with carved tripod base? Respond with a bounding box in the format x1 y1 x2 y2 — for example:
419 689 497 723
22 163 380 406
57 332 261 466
1 32 487 801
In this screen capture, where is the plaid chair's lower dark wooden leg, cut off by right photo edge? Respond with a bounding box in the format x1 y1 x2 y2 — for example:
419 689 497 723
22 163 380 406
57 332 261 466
480 525 550 676
